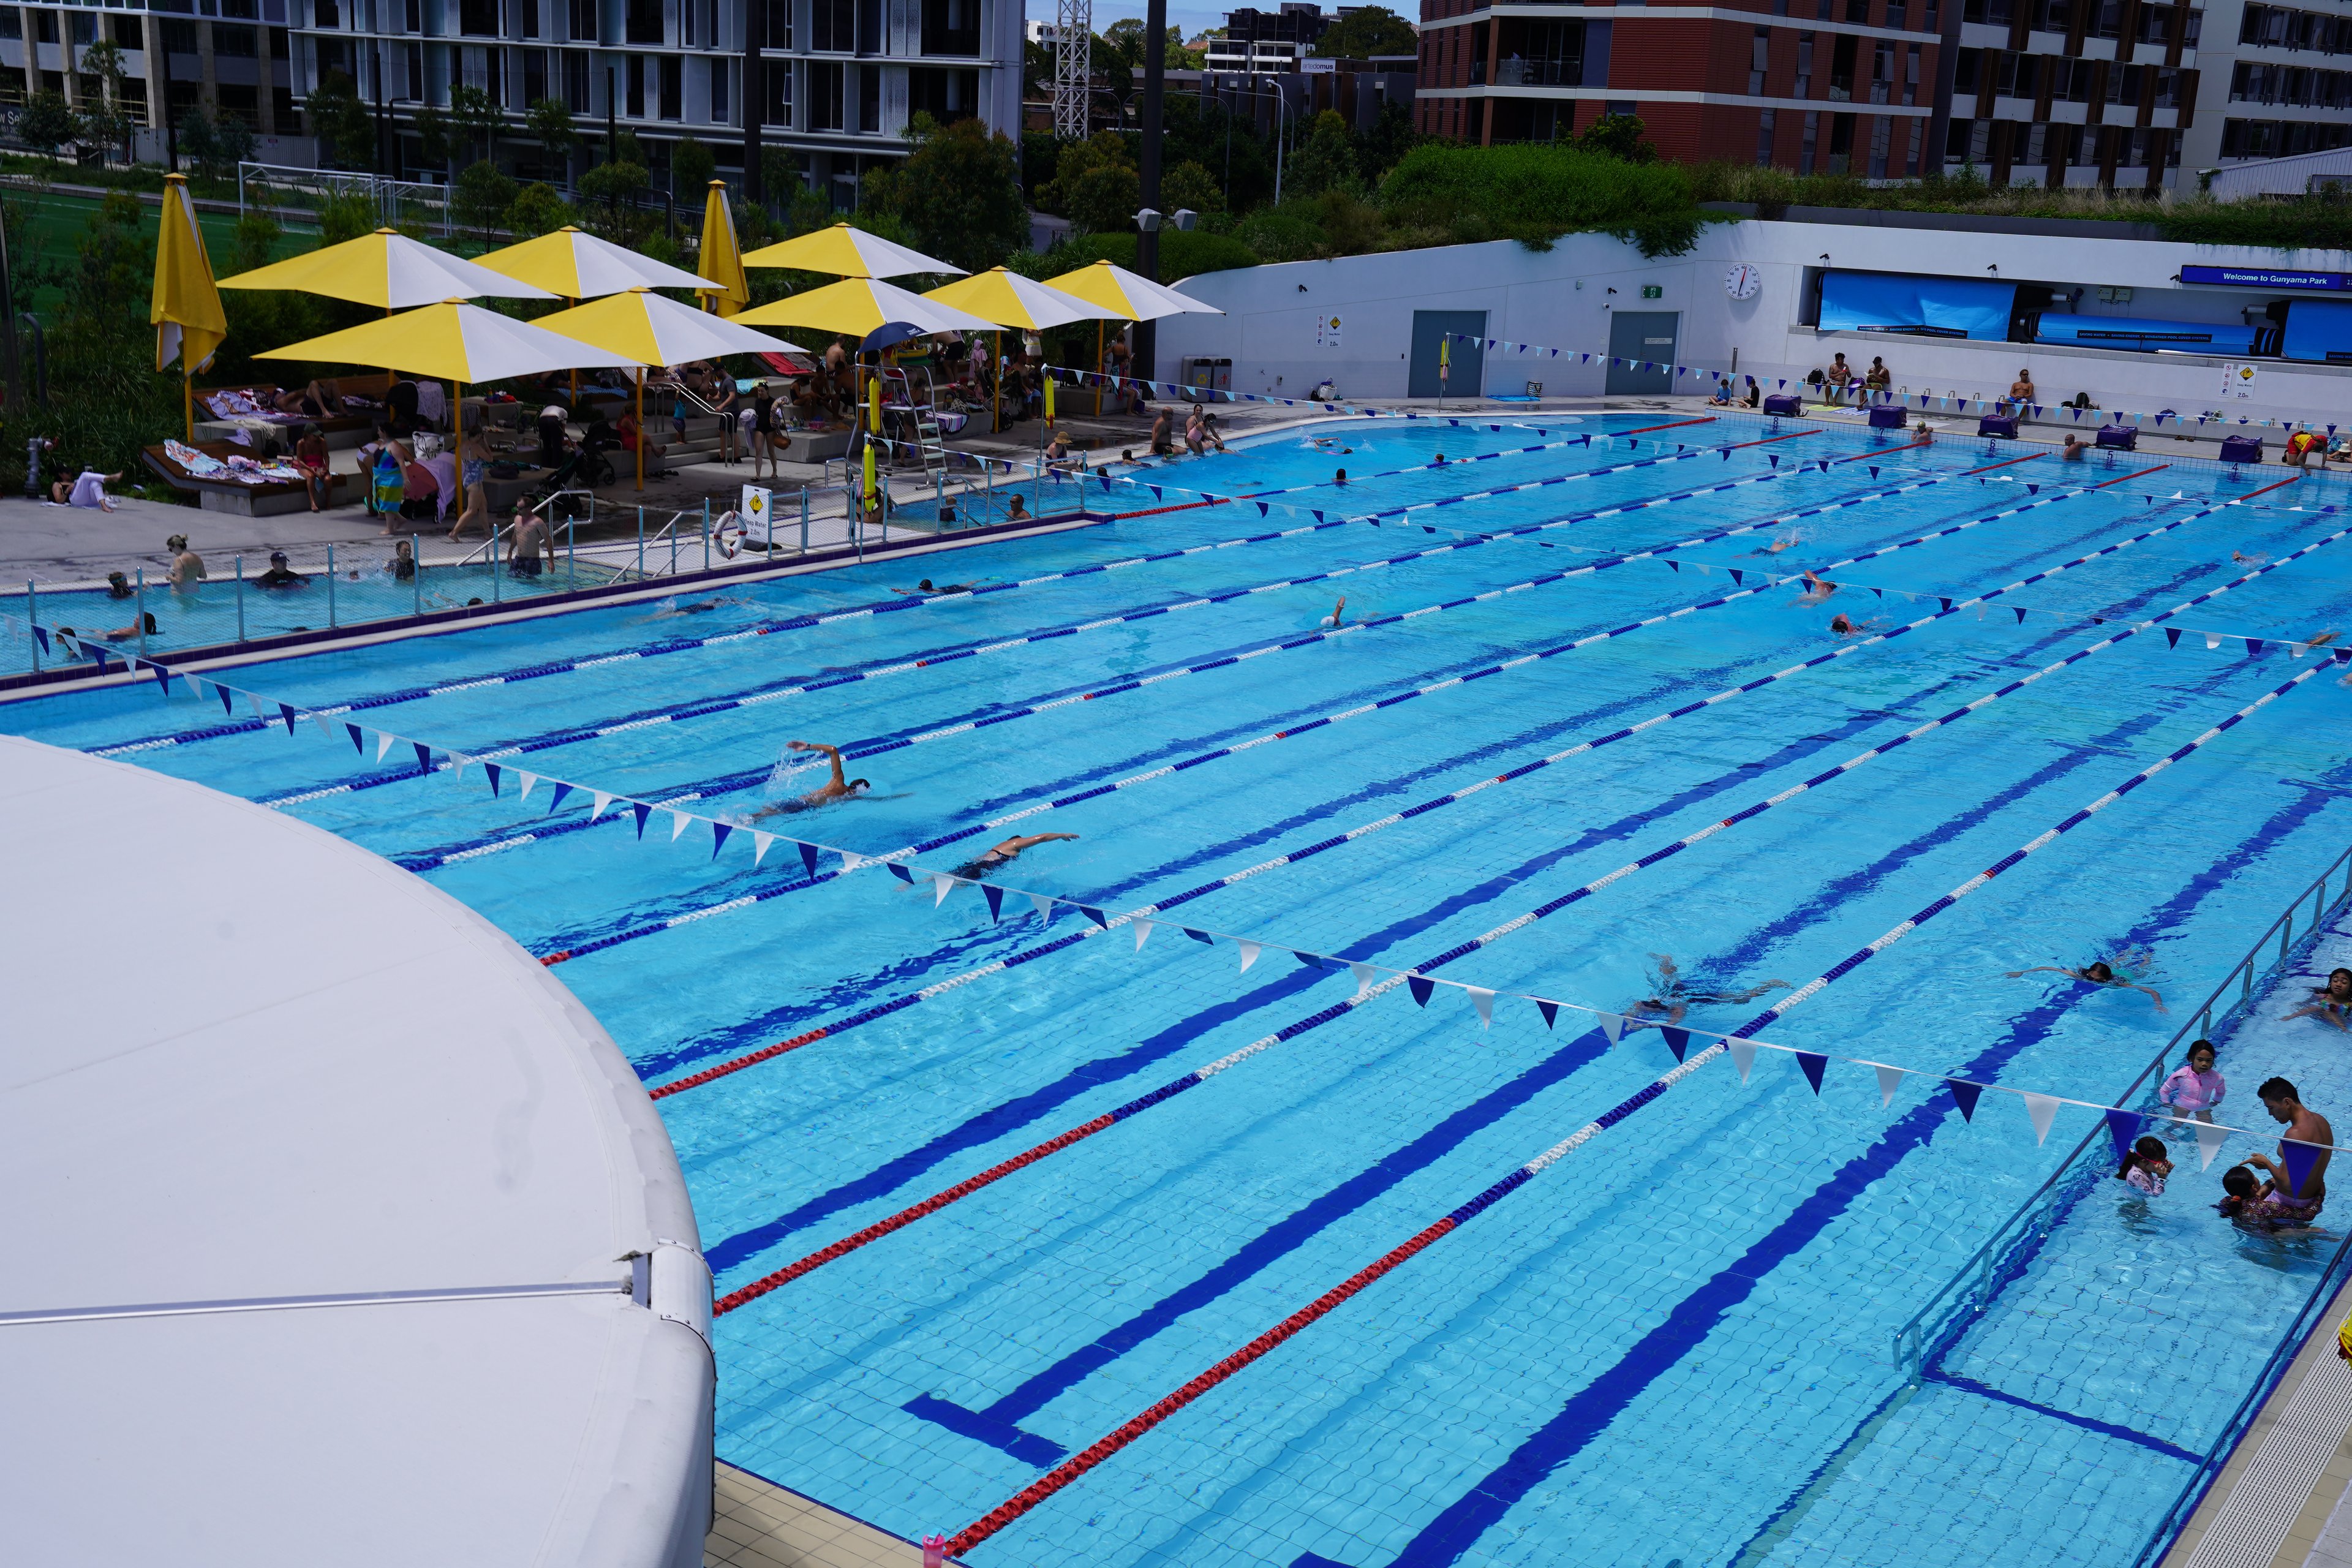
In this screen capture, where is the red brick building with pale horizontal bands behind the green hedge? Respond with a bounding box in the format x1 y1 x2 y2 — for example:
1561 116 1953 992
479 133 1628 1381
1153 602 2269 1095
1414 0 1962 179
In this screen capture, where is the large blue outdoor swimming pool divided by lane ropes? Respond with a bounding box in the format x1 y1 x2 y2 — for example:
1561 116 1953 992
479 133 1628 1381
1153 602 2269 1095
13 414 2352 1568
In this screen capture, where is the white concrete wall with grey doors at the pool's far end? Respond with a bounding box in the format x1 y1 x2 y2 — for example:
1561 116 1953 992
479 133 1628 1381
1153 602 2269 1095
1159 221 2352 423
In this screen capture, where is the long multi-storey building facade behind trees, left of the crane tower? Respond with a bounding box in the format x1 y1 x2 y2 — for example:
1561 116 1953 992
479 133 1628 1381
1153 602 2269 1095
0 0 1023 202
